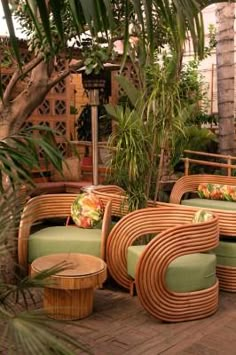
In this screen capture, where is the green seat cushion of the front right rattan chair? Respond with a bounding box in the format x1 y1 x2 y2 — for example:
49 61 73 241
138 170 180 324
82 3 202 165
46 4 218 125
127 245 216 292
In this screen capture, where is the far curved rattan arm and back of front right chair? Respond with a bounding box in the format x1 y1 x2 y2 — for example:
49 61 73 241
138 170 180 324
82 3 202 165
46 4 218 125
107 207 215 289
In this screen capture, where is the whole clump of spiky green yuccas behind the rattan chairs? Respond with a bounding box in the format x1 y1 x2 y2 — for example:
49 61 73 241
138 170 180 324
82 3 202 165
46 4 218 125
106 53 194 208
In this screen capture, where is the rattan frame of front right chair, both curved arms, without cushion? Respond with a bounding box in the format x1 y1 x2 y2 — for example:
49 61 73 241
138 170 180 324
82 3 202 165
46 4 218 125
107 207 219 322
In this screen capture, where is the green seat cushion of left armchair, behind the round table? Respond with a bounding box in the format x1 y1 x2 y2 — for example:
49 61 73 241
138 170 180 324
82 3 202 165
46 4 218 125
28 226 101 263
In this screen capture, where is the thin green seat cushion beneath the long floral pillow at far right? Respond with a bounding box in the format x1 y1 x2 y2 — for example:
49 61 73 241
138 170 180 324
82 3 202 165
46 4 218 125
181 198 236 211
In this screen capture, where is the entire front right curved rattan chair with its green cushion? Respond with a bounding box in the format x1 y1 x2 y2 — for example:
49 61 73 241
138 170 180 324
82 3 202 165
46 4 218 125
107 207 219 322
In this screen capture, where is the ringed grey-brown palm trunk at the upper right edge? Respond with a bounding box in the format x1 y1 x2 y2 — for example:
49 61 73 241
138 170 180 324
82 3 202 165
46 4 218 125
216 2 235 155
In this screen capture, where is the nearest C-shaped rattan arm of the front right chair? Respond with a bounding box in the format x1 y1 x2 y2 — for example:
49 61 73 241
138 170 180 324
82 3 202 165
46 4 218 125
135 216 219 322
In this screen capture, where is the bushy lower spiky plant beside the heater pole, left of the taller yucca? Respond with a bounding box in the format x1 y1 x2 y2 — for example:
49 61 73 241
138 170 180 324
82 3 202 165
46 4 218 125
105 92 150 210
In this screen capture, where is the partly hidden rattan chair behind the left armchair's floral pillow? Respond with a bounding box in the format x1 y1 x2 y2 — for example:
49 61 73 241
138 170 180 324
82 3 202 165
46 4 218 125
92 185 155 217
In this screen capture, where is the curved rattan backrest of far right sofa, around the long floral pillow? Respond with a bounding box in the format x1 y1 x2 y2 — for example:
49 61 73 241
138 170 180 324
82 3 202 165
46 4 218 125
170 174 236 204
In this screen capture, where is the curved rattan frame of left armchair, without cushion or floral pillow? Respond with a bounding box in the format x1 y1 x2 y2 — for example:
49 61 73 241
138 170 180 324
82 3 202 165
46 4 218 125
18 193 111 270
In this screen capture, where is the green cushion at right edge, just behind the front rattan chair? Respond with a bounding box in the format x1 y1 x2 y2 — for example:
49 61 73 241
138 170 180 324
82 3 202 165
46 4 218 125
212 240 236 267
